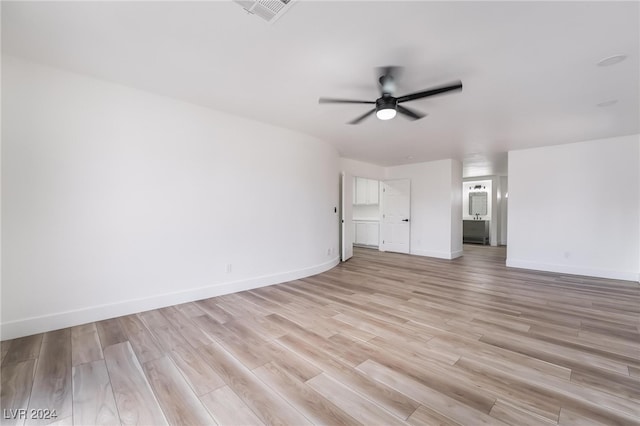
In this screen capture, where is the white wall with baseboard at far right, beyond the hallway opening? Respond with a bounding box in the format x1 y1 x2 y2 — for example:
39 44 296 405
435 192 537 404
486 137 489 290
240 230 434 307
507 135 640 281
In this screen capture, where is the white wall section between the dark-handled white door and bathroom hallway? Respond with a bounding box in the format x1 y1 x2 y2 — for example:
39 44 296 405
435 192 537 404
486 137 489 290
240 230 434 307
386 159 462 259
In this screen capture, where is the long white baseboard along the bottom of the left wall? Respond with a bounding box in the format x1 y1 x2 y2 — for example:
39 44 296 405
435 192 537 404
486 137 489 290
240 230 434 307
0 257 340 340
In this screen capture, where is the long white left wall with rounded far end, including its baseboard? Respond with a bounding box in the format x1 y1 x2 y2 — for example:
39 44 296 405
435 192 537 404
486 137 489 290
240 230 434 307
2 57 339 339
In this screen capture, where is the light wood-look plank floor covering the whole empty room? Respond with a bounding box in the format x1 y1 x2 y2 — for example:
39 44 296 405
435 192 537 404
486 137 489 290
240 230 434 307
1 246 640 426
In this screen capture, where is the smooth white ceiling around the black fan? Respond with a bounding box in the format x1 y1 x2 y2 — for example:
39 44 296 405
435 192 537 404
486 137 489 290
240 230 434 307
2 0 640 176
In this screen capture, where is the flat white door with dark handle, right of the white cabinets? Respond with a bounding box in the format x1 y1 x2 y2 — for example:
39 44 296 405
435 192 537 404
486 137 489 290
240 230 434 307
380 179 411 253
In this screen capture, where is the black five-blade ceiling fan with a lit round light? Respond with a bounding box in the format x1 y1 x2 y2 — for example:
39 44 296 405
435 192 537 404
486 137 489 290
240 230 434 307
318 67 462 124
